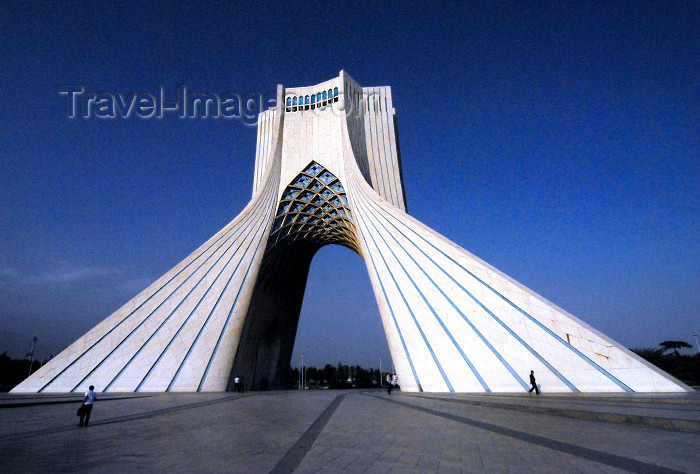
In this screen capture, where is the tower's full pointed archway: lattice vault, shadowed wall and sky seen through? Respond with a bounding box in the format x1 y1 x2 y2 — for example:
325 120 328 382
229 160 391 389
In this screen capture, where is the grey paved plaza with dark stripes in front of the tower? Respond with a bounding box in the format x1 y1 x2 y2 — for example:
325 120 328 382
0 390 700 473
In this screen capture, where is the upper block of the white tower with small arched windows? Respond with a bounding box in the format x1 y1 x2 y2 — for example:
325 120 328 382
253 71 406 211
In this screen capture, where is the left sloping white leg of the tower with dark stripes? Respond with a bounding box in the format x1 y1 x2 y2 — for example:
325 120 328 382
13 101 283 392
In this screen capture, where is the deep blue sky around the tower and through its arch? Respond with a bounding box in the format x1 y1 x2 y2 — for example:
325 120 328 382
0 1 700 367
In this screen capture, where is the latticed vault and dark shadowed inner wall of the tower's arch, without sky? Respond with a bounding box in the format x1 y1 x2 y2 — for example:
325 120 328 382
228 160 360 390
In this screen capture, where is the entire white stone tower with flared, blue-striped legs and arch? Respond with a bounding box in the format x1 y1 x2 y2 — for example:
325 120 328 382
13 71 689 392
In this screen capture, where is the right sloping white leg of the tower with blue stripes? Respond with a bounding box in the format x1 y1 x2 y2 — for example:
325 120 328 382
347 138 685 392
